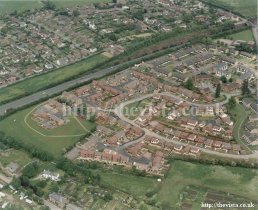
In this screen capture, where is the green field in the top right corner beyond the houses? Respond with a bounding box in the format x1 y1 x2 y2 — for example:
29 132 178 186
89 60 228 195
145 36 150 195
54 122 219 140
206 0 257 18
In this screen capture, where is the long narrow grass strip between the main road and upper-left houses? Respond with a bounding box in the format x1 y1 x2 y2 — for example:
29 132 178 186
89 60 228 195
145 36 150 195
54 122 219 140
0 54 108 103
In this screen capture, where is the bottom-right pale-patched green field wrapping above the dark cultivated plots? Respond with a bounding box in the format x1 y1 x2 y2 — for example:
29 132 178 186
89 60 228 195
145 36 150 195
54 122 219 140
157 161 258 207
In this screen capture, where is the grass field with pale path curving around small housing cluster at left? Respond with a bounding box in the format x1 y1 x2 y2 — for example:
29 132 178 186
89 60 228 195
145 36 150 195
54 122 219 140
0 108 94 156
